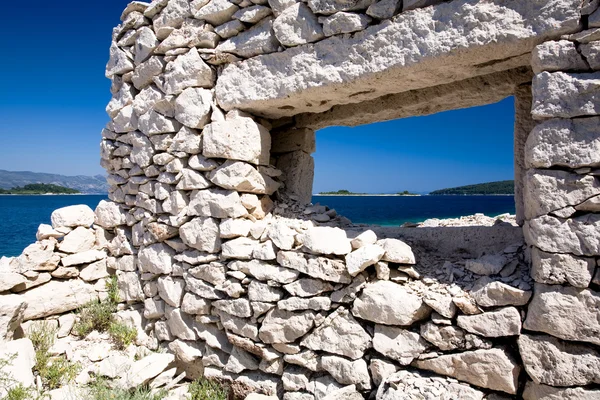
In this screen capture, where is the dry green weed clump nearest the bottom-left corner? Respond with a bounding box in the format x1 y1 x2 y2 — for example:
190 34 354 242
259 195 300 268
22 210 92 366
28 322 79 390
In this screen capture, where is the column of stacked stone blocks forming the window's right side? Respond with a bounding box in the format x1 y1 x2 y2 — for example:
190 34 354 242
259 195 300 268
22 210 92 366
519 15 600 399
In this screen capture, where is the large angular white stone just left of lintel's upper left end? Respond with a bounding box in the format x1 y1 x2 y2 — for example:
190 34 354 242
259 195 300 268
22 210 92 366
162 47 216 94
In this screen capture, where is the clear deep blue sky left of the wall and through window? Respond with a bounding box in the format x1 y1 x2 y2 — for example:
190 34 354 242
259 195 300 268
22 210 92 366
0 0 514 192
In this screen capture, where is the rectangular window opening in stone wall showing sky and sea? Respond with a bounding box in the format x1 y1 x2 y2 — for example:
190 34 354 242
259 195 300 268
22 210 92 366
312 97 515 226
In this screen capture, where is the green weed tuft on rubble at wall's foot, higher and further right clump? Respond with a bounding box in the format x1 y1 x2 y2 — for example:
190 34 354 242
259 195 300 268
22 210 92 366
73 276 137 349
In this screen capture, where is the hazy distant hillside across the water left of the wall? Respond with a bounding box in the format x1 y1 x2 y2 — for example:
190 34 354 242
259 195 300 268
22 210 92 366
0 170 108 194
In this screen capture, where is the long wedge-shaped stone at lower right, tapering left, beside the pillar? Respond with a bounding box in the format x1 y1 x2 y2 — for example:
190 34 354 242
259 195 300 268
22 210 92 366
414 349 521 394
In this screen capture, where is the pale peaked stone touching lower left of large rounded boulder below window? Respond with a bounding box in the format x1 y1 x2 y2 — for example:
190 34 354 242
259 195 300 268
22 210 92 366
301 308 371 359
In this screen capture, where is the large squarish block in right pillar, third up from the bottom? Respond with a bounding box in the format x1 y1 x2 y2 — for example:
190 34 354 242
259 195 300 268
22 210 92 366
523 283 600 344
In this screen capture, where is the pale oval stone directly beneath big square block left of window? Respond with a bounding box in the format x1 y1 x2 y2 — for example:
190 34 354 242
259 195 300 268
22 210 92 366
209 160 280 195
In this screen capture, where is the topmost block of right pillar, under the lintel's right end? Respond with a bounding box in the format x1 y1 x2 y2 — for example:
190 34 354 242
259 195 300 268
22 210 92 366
531 40 588 74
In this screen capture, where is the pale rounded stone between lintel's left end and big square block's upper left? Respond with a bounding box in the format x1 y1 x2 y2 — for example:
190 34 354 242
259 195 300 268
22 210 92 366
175 88 213 129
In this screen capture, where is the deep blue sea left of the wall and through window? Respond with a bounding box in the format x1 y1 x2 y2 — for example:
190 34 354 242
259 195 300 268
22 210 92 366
0 195 515 257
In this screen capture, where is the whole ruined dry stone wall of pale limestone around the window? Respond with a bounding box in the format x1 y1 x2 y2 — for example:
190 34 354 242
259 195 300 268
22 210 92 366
0 0 600 400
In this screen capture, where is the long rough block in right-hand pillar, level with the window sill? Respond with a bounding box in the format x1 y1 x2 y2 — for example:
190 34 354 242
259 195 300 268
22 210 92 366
523 214 600 256
